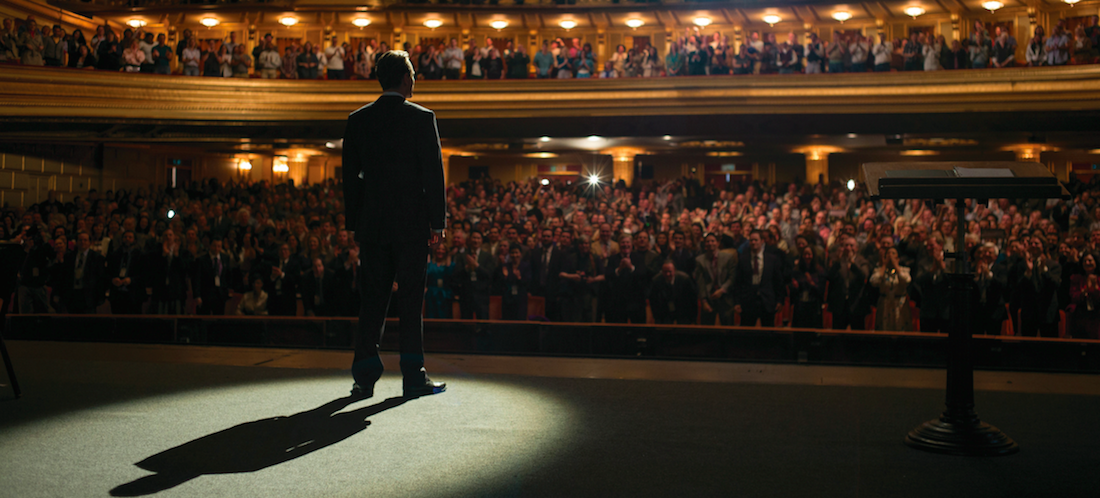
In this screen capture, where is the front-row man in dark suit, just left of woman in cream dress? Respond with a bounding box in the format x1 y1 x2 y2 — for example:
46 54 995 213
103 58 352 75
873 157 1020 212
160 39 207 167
825 235 870 330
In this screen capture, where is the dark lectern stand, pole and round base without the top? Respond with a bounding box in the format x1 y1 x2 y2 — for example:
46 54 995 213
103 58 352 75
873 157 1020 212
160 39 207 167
905 199 1020 456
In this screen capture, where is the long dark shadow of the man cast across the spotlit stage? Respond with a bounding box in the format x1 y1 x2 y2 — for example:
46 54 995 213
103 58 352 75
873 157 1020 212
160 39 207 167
111 397 410 496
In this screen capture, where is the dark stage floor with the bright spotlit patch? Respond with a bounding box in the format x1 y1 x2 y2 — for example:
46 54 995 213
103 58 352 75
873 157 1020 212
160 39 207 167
0 341 1100 498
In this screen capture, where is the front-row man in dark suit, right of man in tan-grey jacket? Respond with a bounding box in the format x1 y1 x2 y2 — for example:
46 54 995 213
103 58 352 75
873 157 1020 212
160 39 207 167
734 230 787 327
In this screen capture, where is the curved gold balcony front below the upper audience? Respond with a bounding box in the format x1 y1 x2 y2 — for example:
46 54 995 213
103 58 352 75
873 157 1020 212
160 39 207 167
0 65 1100 125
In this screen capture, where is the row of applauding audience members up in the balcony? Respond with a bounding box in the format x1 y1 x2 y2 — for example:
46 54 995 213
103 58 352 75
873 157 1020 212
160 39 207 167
0 15 1100 76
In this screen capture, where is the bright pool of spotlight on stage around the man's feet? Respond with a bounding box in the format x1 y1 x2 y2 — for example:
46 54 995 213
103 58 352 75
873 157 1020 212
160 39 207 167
0 373 578 497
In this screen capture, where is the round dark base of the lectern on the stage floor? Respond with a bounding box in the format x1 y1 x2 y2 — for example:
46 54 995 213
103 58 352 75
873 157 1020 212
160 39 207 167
905 419 1020 456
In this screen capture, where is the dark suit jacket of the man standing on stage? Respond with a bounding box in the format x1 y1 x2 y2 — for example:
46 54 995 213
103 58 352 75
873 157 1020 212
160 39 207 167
343 93 447 243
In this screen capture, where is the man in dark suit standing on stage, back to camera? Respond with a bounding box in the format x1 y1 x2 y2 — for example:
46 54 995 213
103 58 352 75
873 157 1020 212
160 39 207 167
343 51 447 397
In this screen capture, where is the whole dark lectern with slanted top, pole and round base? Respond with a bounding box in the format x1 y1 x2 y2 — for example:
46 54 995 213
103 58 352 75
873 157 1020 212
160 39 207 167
862 162 1069 456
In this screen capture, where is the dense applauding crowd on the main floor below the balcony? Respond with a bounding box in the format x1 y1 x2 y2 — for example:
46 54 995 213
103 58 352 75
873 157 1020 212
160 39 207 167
0 169 1100 339
